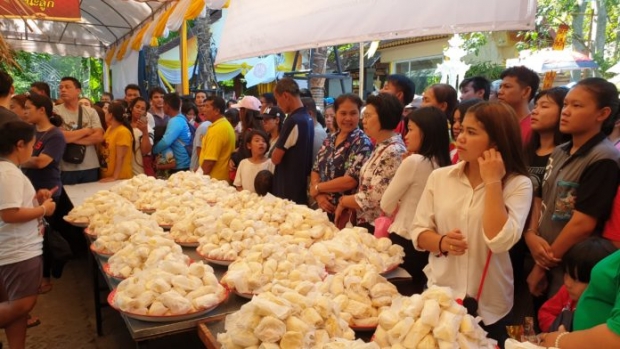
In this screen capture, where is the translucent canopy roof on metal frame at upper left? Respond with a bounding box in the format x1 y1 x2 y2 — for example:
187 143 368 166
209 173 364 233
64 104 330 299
0 0 170 58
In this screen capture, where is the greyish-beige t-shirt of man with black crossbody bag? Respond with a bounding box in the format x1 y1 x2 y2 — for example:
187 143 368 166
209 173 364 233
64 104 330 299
54 104 103 172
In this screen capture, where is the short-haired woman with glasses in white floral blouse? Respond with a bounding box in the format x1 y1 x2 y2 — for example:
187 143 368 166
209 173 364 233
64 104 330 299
336 93 407 233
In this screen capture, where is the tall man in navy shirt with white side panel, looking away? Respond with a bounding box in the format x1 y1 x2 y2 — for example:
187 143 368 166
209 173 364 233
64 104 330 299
271 78 314 204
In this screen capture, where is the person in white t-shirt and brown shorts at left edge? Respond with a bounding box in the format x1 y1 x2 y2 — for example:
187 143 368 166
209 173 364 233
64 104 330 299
0 121 56 348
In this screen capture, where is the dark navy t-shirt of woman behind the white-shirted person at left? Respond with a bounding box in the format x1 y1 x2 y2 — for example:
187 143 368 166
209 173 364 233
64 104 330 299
24 127 67 197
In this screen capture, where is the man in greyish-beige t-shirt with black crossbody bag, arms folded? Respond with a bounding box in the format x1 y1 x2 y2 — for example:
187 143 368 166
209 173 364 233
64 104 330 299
54 77 103 185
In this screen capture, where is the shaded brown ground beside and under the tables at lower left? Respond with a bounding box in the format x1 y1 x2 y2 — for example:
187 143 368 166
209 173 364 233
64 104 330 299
0 253 204 349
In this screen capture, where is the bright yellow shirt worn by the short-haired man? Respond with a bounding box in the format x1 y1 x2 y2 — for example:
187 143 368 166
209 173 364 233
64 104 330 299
198 117 235 182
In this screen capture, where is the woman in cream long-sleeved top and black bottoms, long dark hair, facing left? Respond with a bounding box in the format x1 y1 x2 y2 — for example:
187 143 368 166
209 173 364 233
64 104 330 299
381 107 452 293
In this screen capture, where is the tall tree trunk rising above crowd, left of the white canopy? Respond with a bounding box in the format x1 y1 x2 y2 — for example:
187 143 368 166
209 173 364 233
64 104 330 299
194 16 217 89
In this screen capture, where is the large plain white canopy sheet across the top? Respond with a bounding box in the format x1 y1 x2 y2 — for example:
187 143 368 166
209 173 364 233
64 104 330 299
215 0 536 63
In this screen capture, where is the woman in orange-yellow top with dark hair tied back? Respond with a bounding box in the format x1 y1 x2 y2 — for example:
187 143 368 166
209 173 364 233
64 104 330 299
100 102 134 182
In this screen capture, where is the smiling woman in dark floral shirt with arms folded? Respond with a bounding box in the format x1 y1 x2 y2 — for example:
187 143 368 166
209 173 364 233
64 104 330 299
310 93 372 215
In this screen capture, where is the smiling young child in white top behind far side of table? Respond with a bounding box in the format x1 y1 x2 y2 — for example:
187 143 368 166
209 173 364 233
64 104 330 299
233 130 275 193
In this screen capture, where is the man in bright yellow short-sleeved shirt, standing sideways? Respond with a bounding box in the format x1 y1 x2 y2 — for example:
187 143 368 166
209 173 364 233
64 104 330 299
199 96 235 182
